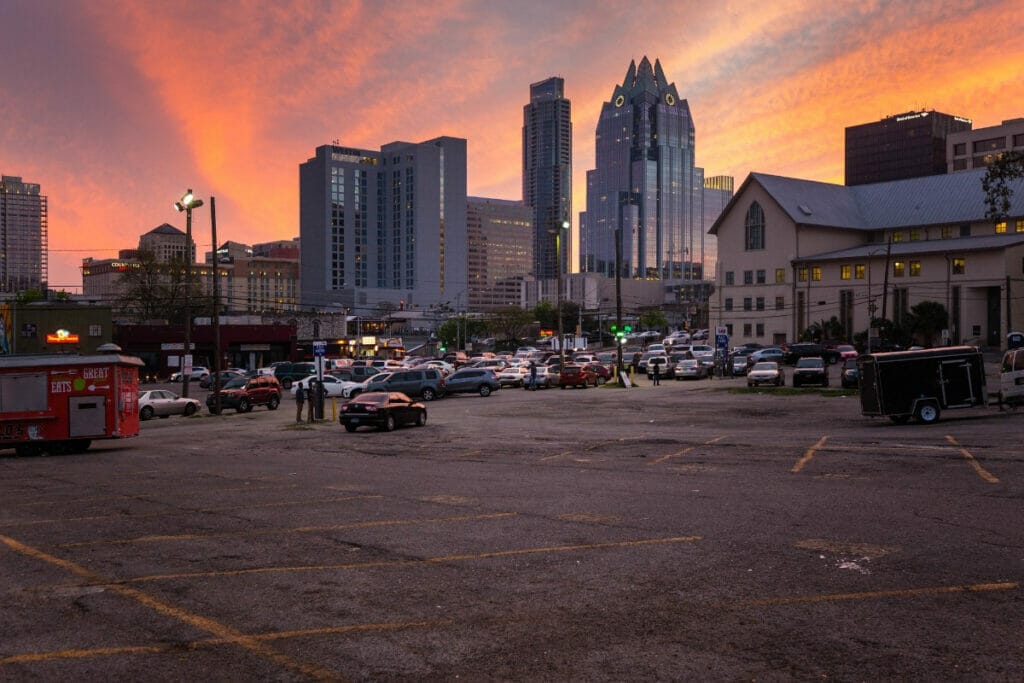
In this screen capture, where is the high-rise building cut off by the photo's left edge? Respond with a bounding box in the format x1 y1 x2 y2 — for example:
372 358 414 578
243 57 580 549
0 175 48 297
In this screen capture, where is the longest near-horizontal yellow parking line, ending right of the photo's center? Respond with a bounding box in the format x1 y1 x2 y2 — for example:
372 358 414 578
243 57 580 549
88 536 702 584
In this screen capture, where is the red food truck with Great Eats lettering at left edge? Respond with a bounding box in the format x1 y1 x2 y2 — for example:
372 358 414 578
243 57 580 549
0 353 143 456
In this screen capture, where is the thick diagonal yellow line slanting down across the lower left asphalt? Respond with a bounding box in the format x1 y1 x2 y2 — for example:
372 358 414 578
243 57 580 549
0 536 339 680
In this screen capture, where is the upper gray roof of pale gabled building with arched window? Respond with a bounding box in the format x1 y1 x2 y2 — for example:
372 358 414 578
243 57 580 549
712 169 1024 232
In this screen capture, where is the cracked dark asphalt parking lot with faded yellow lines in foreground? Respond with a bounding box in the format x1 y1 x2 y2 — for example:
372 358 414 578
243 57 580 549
0 380 1024 680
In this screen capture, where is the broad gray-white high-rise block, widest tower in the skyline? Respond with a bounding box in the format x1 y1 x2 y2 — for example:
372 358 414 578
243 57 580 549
299 137 467 315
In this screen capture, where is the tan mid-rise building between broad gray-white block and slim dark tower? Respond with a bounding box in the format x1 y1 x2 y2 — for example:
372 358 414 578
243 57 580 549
466 197 535 311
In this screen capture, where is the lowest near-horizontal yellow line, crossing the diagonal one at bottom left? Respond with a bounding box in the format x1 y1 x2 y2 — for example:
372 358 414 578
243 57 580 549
0 620 455 667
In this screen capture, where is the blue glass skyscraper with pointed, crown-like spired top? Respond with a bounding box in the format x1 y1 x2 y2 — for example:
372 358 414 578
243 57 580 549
580 56 703 280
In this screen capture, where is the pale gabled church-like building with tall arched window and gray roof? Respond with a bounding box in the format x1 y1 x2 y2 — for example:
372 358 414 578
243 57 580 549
711 169 1024 348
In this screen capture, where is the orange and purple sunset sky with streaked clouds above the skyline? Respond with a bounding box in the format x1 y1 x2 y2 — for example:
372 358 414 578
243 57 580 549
0 0 1024 291
